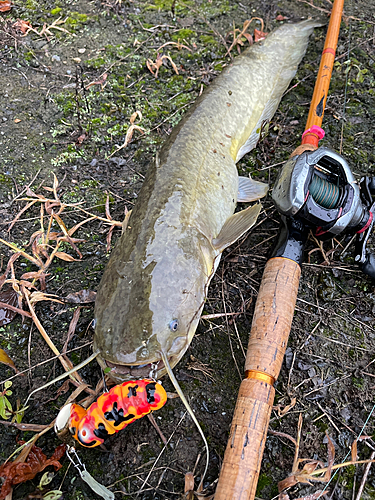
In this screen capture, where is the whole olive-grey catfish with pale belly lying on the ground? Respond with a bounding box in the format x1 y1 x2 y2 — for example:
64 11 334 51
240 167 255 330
94 17 317 382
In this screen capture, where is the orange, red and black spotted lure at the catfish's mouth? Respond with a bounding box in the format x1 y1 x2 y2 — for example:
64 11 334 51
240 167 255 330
55 379 167 448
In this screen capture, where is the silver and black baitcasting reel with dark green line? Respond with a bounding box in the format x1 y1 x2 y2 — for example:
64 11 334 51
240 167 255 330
272 148 375 279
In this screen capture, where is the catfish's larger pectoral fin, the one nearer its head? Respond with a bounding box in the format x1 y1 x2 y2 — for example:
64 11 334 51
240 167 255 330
212 203 262 252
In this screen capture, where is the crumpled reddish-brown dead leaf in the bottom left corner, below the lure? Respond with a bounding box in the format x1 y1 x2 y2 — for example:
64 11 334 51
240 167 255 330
0 442 66 500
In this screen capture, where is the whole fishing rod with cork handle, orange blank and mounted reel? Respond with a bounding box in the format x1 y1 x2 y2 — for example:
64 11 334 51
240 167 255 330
215 0 375 500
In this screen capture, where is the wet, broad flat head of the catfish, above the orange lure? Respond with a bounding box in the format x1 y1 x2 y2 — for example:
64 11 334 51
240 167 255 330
94 232 212 383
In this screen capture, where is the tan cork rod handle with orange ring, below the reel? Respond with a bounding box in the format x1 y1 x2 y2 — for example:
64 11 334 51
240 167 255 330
215 257 301 500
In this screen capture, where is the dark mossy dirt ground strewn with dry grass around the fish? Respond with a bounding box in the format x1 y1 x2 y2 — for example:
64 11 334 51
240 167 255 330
0 0 375 500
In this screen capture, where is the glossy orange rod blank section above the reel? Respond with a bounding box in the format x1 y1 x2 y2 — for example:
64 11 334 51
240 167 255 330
302 0 344 147
